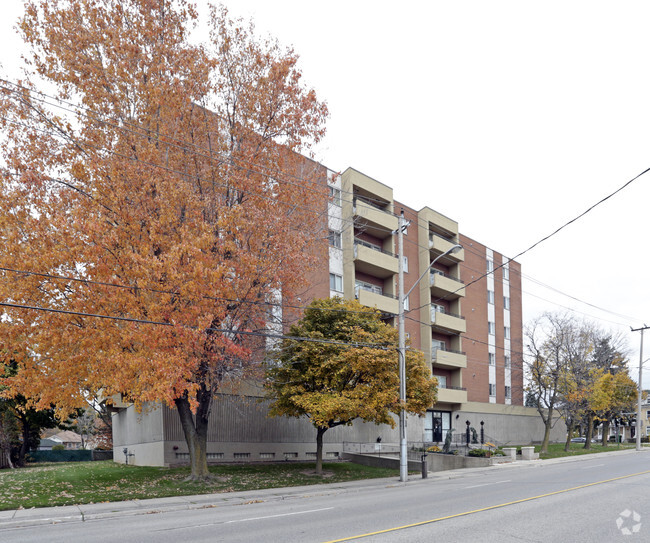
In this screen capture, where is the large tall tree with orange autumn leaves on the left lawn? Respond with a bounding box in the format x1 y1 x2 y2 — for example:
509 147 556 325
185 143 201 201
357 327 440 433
0 0 327 478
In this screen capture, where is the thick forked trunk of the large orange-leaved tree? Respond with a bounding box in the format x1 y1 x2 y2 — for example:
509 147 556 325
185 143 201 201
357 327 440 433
174 385 212 481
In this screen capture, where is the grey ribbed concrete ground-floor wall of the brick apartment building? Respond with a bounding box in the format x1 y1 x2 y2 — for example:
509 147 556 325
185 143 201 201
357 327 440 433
113 395 565 466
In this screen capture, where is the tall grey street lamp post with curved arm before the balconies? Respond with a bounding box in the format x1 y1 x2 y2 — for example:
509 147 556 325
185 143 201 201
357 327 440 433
397 212 462 483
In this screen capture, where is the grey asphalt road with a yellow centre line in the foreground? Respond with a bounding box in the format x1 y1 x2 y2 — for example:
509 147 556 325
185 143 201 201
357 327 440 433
0 452 650 543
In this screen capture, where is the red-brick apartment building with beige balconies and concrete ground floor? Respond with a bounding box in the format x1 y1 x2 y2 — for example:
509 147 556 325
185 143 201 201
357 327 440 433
113 164 565 465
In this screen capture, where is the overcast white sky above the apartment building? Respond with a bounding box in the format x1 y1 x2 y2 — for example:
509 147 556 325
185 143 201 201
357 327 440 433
0 0 650 378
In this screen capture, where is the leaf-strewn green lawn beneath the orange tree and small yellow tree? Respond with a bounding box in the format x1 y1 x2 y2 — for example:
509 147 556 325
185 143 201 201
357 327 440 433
0 461 399 510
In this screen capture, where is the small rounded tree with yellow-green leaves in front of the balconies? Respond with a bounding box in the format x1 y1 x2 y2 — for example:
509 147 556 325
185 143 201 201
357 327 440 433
266 297 437 474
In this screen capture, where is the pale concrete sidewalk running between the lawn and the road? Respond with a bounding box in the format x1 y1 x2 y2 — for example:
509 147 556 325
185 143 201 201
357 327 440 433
0 449 650 531
